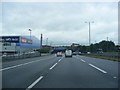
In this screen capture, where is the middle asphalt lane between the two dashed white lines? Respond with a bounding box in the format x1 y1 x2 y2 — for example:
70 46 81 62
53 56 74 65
33 57 118 88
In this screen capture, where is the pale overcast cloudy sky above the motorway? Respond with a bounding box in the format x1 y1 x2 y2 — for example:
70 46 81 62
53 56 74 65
0 2 118 45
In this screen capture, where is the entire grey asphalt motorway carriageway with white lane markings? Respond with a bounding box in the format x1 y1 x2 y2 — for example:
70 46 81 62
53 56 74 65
0 55 118 90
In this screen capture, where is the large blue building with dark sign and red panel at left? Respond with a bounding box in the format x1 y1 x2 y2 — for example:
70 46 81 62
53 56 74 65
0 36 41 53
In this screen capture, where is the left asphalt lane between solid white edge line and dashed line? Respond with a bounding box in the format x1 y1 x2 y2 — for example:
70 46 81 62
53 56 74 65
2 56 60 88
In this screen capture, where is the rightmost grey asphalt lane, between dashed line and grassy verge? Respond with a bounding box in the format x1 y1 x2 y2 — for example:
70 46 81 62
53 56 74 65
76 55 120 78
